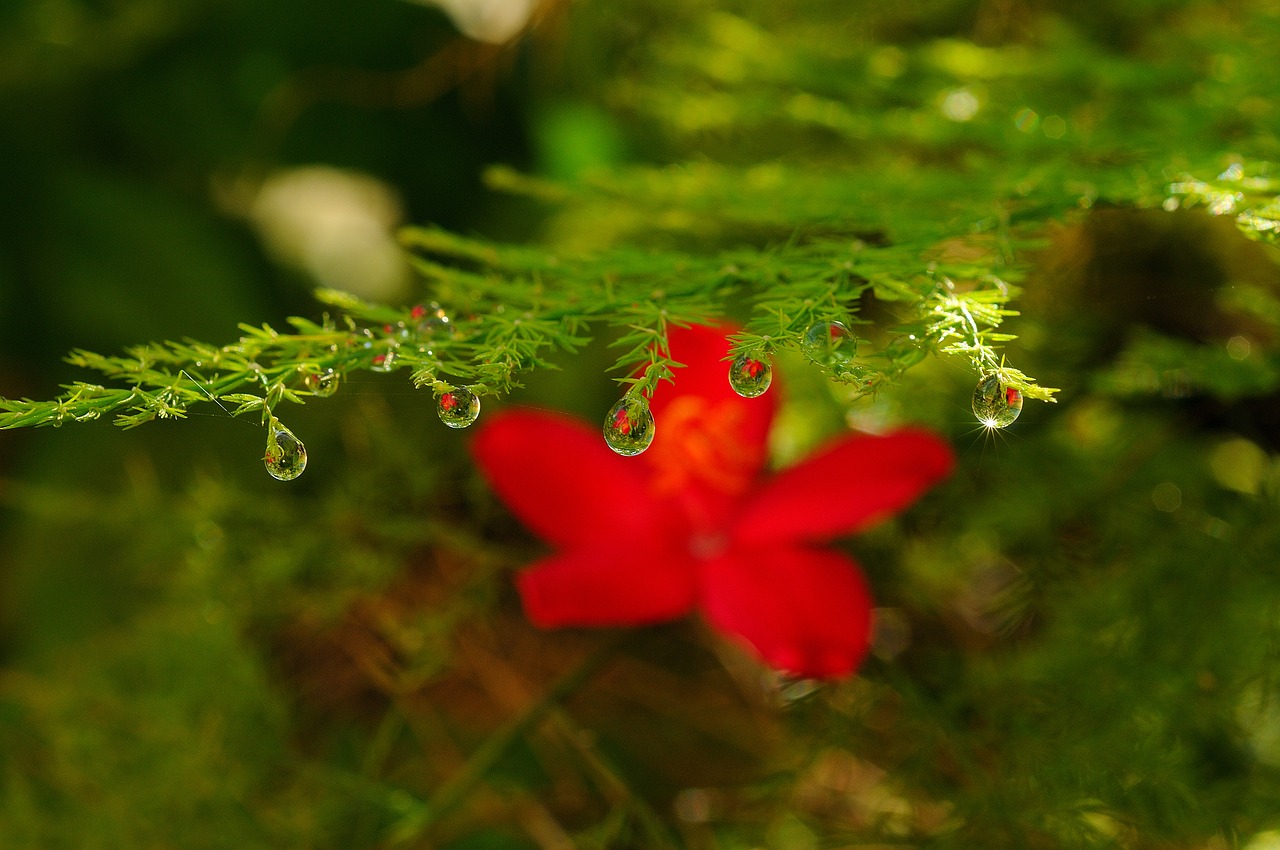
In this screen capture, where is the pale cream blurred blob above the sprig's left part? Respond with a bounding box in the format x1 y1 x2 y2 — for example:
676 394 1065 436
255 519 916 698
250 165 408 301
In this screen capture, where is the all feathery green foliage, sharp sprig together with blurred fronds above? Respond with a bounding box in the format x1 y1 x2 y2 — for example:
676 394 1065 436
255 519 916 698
10 0 1280 428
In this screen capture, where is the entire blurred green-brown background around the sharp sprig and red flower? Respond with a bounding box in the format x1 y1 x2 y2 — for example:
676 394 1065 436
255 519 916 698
0 0 1280 850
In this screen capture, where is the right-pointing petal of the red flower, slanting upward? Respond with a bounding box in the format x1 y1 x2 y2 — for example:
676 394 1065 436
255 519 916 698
733 429 954 544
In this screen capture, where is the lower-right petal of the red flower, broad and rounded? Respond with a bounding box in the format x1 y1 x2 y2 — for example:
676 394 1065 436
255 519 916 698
701 547 872 678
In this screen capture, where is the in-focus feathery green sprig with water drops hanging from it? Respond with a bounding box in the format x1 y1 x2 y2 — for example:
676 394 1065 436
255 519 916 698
0 230 1053 428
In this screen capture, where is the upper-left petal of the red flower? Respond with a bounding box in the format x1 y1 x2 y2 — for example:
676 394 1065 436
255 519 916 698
471 411 669 545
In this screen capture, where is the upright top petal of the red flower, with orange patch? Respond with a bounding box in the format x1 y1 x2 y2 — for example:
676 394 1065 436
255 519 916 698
640 326 777 530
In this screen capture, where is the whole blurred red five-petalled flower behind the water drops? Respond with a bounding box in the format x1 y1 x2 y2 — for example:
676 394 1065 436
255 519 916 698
472 328 952 677
